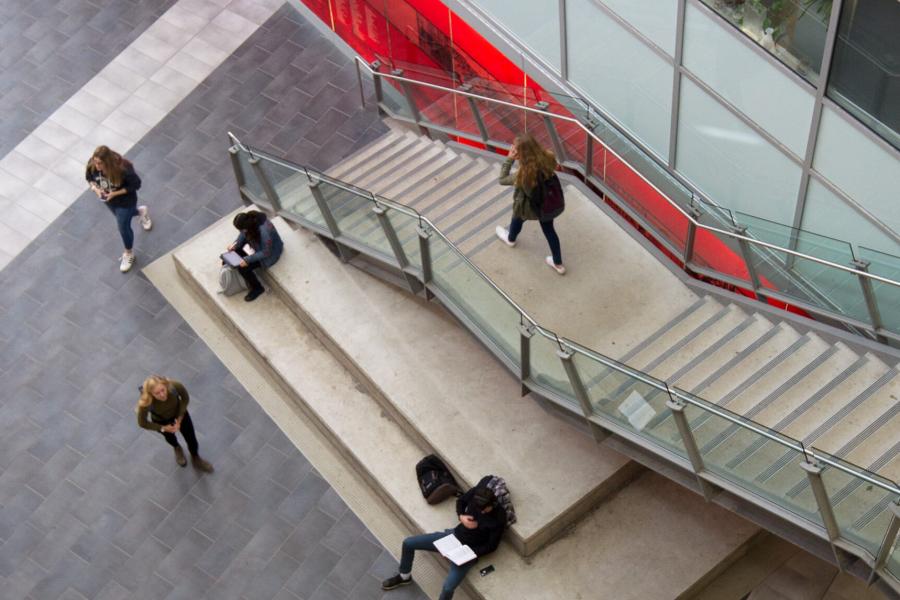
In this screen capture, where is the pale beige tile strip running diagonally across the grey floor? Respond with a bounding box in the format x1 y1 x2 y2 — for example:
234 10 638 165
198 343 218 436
0 0 284 269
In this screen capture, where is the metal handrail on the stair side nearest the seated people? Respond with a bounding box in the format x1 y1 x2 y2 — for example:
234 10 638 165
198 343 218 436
228 132 900 495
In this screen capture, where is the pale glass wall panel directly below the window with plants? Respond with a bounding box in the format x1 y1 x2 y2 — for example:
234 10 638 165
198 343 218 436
683 5 815 157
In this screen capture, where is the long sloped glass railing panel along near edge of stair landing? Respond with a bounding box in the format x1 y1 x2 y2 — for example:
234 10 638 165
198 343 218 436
430 233 520 364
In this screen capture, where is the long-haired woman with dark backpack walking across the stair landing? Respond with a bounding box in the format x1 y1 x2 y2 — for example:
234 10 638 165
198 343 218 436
495 133 566 275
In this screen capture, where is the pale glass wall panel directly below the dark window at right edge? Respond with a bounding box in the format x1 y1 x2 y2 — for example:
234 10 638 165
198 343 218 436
813 107 900 246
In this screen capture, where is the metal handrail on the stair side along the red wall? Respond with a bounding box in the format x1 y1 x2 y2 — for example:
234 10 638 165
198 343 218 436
355 56 900 287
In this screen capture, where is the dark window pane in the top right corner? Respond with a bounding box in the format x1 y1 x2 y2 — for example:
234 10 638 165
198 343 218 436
828 0 900 148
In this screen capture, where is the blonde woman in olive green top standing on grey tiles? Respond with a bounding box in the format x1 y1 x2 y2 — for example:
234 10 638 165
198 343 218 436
137 375 213 473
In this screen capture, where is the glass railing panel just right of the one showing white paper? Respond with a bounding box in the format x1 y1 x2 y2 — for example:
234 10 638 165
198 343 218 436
679 391 823 526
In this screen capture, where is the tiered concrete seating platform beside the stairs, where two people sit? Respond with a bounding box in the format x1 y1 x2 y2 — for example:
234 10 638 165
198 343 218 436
167 216 756 600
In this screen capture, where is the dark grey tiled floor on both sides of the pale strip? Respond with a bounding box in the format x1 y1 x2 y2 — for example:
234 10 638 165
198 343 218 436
0 0 424 600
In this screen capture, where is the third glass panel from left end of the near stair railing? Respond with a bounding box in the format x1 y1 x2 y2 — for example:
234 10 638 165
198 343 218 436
319 180 394 263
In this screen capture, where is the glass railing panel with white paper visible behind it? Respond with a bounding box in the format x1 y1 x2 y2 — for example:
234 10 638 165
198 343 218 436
573 352 687 459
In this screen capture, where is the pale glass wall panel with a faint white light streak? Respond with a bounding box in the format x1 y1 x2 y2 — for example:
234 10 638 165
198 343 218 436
676 78 800 223
